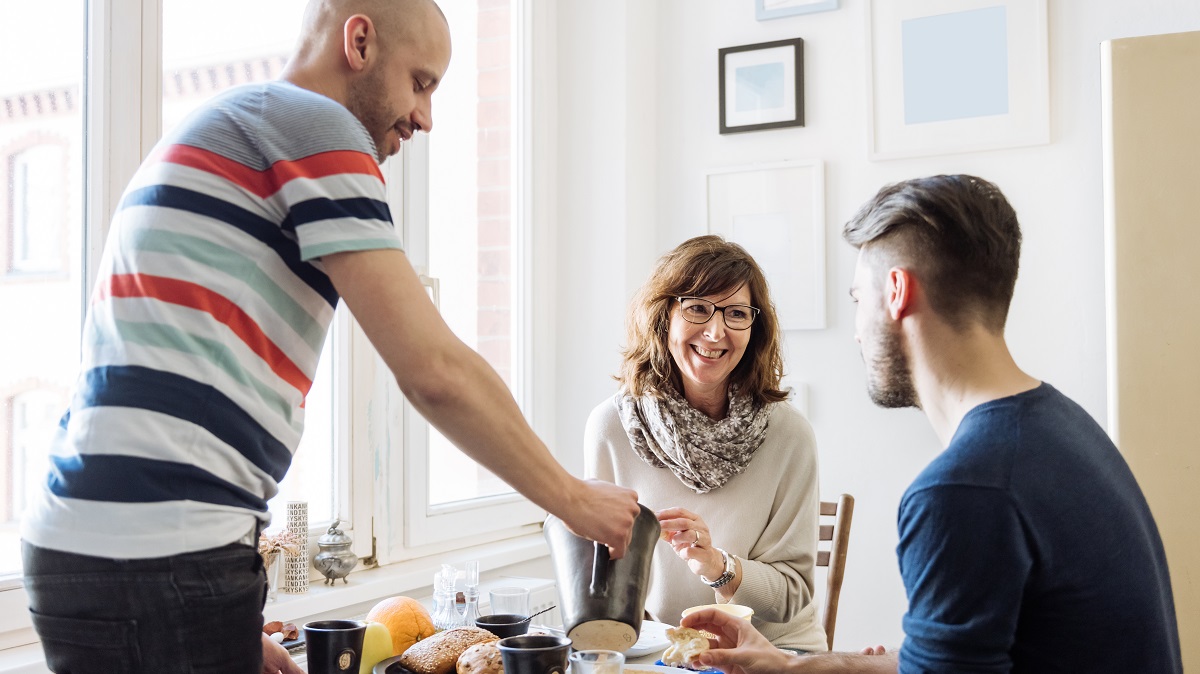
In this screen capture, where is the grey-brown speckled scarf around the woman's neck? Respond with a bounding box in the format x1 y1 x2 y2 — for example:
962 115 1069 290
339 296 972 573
617 387 772 494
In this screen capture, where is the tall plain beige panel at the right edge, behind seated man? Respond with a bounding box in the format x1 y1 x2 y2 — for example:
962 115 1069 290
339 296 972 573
1102 27 1200 672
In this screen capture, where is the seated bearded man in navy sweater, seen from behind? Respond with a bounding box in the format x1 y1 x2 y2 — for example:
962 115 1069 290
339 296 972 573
684 175 1182 674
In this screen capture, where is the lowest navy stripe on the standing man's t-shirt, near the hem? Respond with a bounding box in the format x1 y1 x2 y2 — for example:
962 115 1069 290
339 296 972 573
48 455 266 512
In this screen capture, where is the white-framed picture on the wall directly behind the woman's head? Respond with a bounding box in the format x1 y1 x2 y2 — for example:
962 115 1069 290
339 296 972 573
707 161 826 330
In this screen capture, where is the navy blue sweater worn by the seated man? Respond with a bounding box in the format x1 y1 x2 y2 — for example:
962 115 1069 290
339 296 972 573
896 384 1183 674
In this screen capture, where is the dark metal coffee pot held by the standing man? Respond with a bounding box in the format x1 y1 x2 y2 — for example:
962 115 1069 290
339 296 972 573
544 506 661 652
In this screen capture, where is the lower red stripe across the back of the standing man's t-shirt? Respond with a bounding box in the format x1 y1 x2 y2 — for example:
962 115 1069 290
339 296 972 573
94 273 312 396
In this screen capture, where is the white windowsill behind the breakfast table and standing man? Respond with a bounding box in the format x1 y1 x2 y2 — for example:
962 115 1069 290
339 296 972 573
0 532 548 674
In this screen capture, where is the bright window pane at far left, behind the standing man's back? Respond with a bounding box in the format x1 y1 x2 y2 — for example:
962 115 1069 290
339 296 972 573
0 0 84 578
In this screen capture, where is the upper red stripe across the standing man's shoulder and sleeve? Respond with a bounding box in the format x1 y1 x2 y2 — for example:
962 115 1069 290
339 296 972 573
146 145 383 199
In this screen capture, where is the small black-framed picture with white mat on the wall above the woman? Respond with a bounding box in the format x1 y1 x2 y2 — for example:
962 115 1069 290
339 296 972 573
718 37 804 133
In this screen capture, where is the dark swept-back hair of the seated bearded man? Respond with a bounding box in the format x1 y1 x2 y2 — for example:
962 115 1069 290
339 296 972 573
842 175 1021 332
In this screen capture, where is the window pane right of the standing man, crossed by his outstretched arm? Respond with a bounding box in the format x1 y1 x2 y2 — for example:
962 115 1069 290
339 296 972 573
391 0 545 555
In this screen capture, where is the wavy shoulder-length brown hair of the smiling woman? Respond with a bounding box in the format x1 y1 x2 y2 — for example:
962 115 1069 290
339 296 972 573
616 235 787 404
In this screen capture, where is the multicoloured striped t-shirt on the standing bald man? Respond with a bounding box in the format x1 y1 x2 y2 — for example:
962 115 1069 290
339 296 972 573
22 82 401 558
